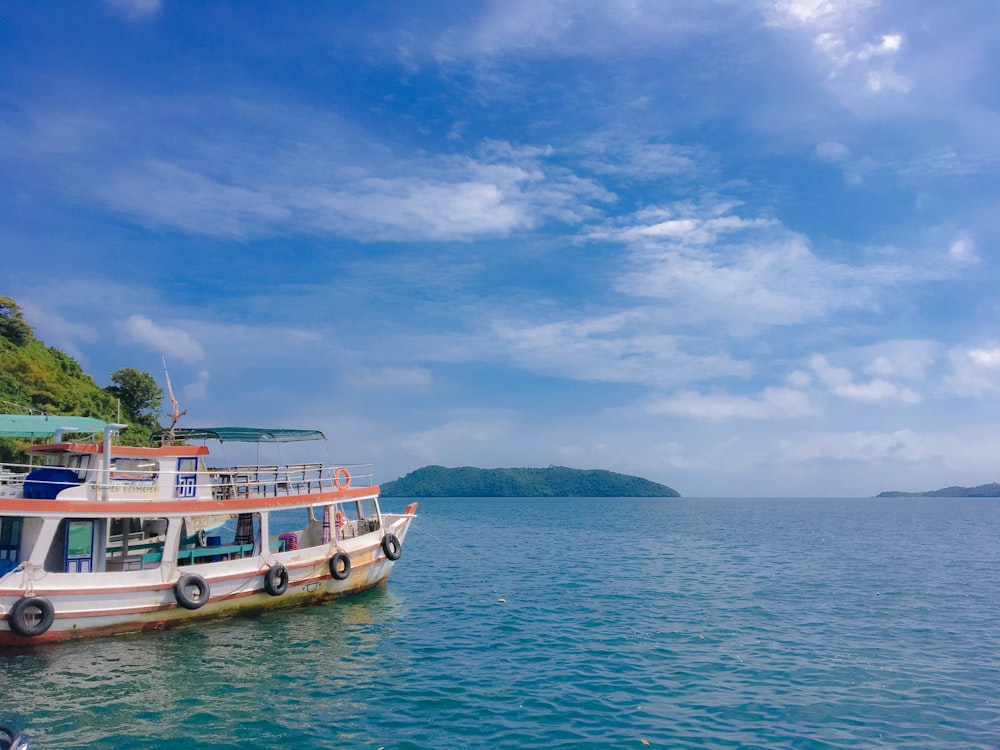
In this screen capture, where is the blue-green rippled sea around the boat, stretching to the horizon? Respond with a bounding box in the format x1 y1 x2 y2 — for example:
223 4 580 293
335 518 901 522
0 498 1000 750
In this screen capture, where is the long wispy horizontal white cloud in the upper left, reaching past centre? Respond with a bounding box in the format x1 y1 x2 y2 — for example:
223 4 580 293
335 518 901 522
96 141 613 242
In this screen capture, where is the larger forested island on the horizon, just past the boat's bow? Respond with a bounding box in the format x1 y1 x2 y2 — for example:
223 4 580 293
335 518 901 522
382 466 680 497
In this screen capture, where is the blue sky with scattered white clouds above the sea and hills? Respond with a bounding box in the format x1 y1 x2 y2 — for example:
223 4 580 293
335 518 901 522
0 0 1000 496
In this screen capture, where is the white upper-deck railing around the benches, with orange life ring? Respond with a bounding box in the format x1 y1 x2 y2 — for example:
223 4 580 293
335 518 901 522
208 463 374 500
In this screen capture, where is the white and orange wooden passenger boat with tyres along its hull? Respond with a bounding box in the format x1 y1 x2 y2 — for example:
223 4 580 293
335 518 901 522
0 415 417 645
